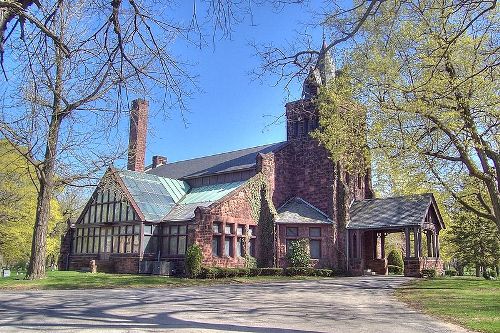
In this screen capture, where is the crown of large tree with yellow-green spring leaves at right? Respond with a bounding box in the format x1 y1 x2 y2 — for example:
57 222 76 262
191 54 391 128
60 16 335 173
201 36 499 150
346 0 500 226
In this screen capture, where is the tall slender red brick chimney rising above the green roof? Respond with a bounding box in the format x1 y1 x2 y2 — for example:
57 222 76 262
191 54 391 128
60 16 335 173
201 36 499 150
127 99 148 172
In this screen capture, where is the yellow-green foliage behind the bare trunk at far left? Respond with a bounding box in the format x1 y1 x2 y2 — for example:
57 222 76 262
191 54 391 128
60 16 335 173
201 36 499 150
0 140 65 266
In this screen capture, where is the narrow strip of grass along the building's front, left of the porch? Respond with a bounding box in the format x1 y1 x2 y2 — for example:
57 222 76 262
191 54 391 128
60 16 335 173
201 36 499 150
0 271 320 292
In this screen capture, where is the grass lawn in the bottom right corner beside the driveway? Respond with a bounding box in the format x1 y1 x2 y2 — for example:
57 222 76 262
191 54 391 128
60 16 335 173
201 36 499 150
396 277 500 333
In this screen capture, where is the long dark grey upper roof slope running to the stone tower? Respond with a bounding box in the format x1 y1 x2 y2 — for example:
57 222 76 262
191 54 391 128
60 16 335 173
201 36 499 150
146 142 286 179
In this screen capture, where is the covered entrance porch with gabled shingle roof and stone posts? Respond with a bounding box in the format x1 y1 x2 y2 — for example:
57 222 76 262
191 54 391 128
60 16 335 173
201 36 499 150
346 194 444 276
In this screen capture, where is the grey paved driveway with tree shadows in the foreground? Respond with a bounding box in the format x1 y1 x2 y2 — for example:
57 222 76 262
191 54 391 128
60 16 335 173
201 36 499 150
0 277 467 333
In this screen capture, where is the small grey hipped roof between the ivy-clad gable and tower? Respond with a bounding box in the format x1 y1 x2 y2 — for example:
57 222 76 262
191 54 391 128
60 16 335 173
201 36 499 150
276 198 332 223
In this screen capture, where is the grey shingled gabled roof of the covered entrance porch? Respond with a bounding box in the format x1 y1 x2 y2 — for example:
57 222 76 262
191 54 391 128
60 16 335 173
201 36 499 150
347 193 442 229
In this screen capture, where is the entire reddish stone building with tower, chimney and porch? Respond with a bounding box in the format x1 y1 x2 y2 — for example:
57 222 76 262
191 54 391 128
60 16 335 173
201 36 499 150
60 48 444 275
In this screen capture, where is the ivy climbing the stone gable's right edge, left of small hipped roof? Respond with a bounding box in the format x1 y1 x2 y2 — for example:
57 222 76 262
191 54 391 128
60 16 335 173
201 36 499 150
246 173 277 267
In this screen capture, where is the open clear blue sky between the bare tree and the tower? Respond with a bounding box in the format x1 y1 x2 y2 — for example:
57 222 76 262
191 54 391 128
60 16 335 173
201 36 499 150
146 4 322 163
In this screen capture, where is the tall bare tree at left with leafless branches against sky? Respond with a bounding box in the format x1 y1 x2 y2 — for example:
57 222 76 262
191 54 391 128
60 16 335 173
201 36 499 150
0 0 272 279
